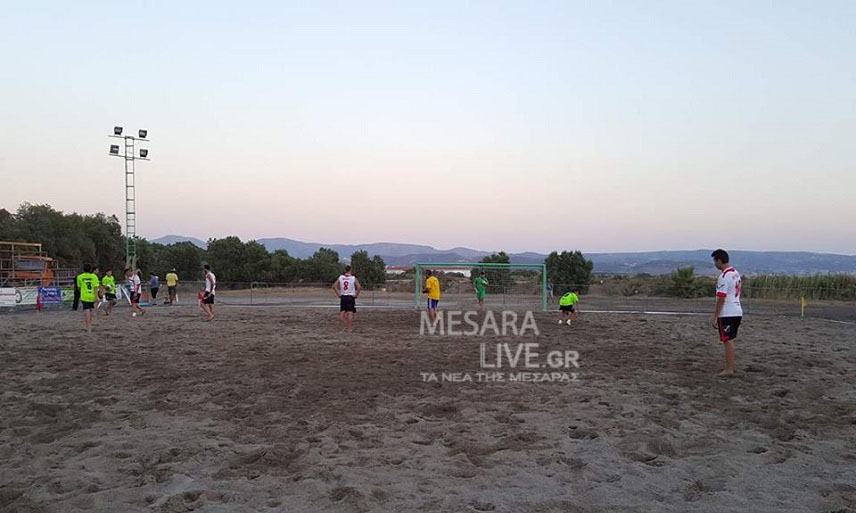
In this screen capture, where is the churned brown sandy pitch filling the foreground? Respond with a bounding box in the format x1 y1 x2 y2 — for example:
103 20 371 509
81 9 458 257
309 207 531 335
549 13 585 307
0 307 856 513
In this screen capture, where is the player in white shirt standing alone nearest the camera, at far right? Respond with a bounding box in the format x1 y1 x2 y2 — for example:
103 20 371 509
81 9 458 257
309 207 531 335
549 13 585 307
710 249 743 376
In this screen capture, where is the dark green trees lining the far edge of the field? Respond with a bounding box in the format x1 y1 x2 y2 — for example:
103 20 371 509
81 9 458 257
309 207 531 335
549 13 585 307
0 203 593 294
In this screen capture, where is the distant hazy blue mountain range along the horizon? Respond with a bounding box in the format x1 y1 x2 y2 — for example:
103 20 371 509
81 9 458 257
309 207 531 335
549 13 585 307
152 235 856 275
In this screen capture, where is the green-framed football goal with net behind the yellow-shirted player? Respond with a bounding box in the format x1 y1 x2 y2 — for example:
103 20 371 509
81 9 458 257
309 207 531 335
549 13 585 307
413 262 547 311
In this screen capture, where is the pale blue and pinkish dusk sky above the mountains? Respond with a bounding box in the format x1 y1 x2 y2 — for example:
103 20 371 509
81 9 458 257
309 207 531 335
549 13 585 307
0 0 856 254
